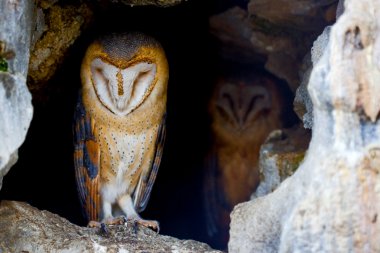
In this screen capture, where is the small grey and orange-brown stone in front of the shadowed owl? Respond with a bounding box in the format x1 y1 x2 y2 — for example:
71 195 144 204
251 126 311 199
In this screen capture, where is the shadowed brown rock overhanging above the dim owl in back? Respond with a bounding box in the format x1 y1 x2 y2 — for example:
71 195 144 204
210 0 337 91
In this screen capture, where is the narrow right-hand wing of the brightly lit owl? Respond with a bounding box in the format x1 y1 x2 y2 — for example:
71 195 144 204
134 114 166 213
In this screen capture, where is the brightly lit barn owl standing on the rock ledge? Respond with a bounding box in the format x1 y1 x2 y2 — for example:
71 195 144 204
74 33 168 231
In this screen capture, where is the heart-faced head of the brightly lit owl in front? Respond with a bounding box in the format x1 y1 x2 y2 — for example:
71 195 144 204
81 33 168 116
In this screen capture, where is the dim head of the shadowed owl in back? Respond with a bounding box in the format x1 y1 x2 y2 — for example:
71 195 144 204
210 74 280 133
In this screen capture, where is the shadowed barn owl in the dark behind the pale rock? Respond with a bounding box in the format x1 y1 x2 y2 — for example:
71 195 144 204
204 74 281 248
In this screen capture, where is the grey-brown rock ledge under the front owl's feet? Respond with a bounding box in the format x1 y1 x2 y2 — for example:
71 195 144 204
0 201 219 253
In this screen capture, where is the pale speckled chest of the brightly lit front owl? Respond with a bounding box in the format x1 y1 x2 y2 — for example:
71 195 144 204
97 123 157 188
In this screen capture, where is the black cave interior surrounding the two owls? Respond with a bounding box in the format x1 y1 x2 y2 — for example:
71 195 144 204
0 0 337 251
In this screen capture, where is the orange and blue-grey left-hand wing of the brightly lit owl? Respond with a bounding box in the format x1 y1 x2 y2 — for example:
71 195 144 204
73 95 100 221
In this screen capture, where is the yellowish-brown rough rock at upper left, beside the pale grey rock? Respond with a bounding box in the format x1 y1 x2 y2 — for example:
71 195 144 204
28 1 92 91
